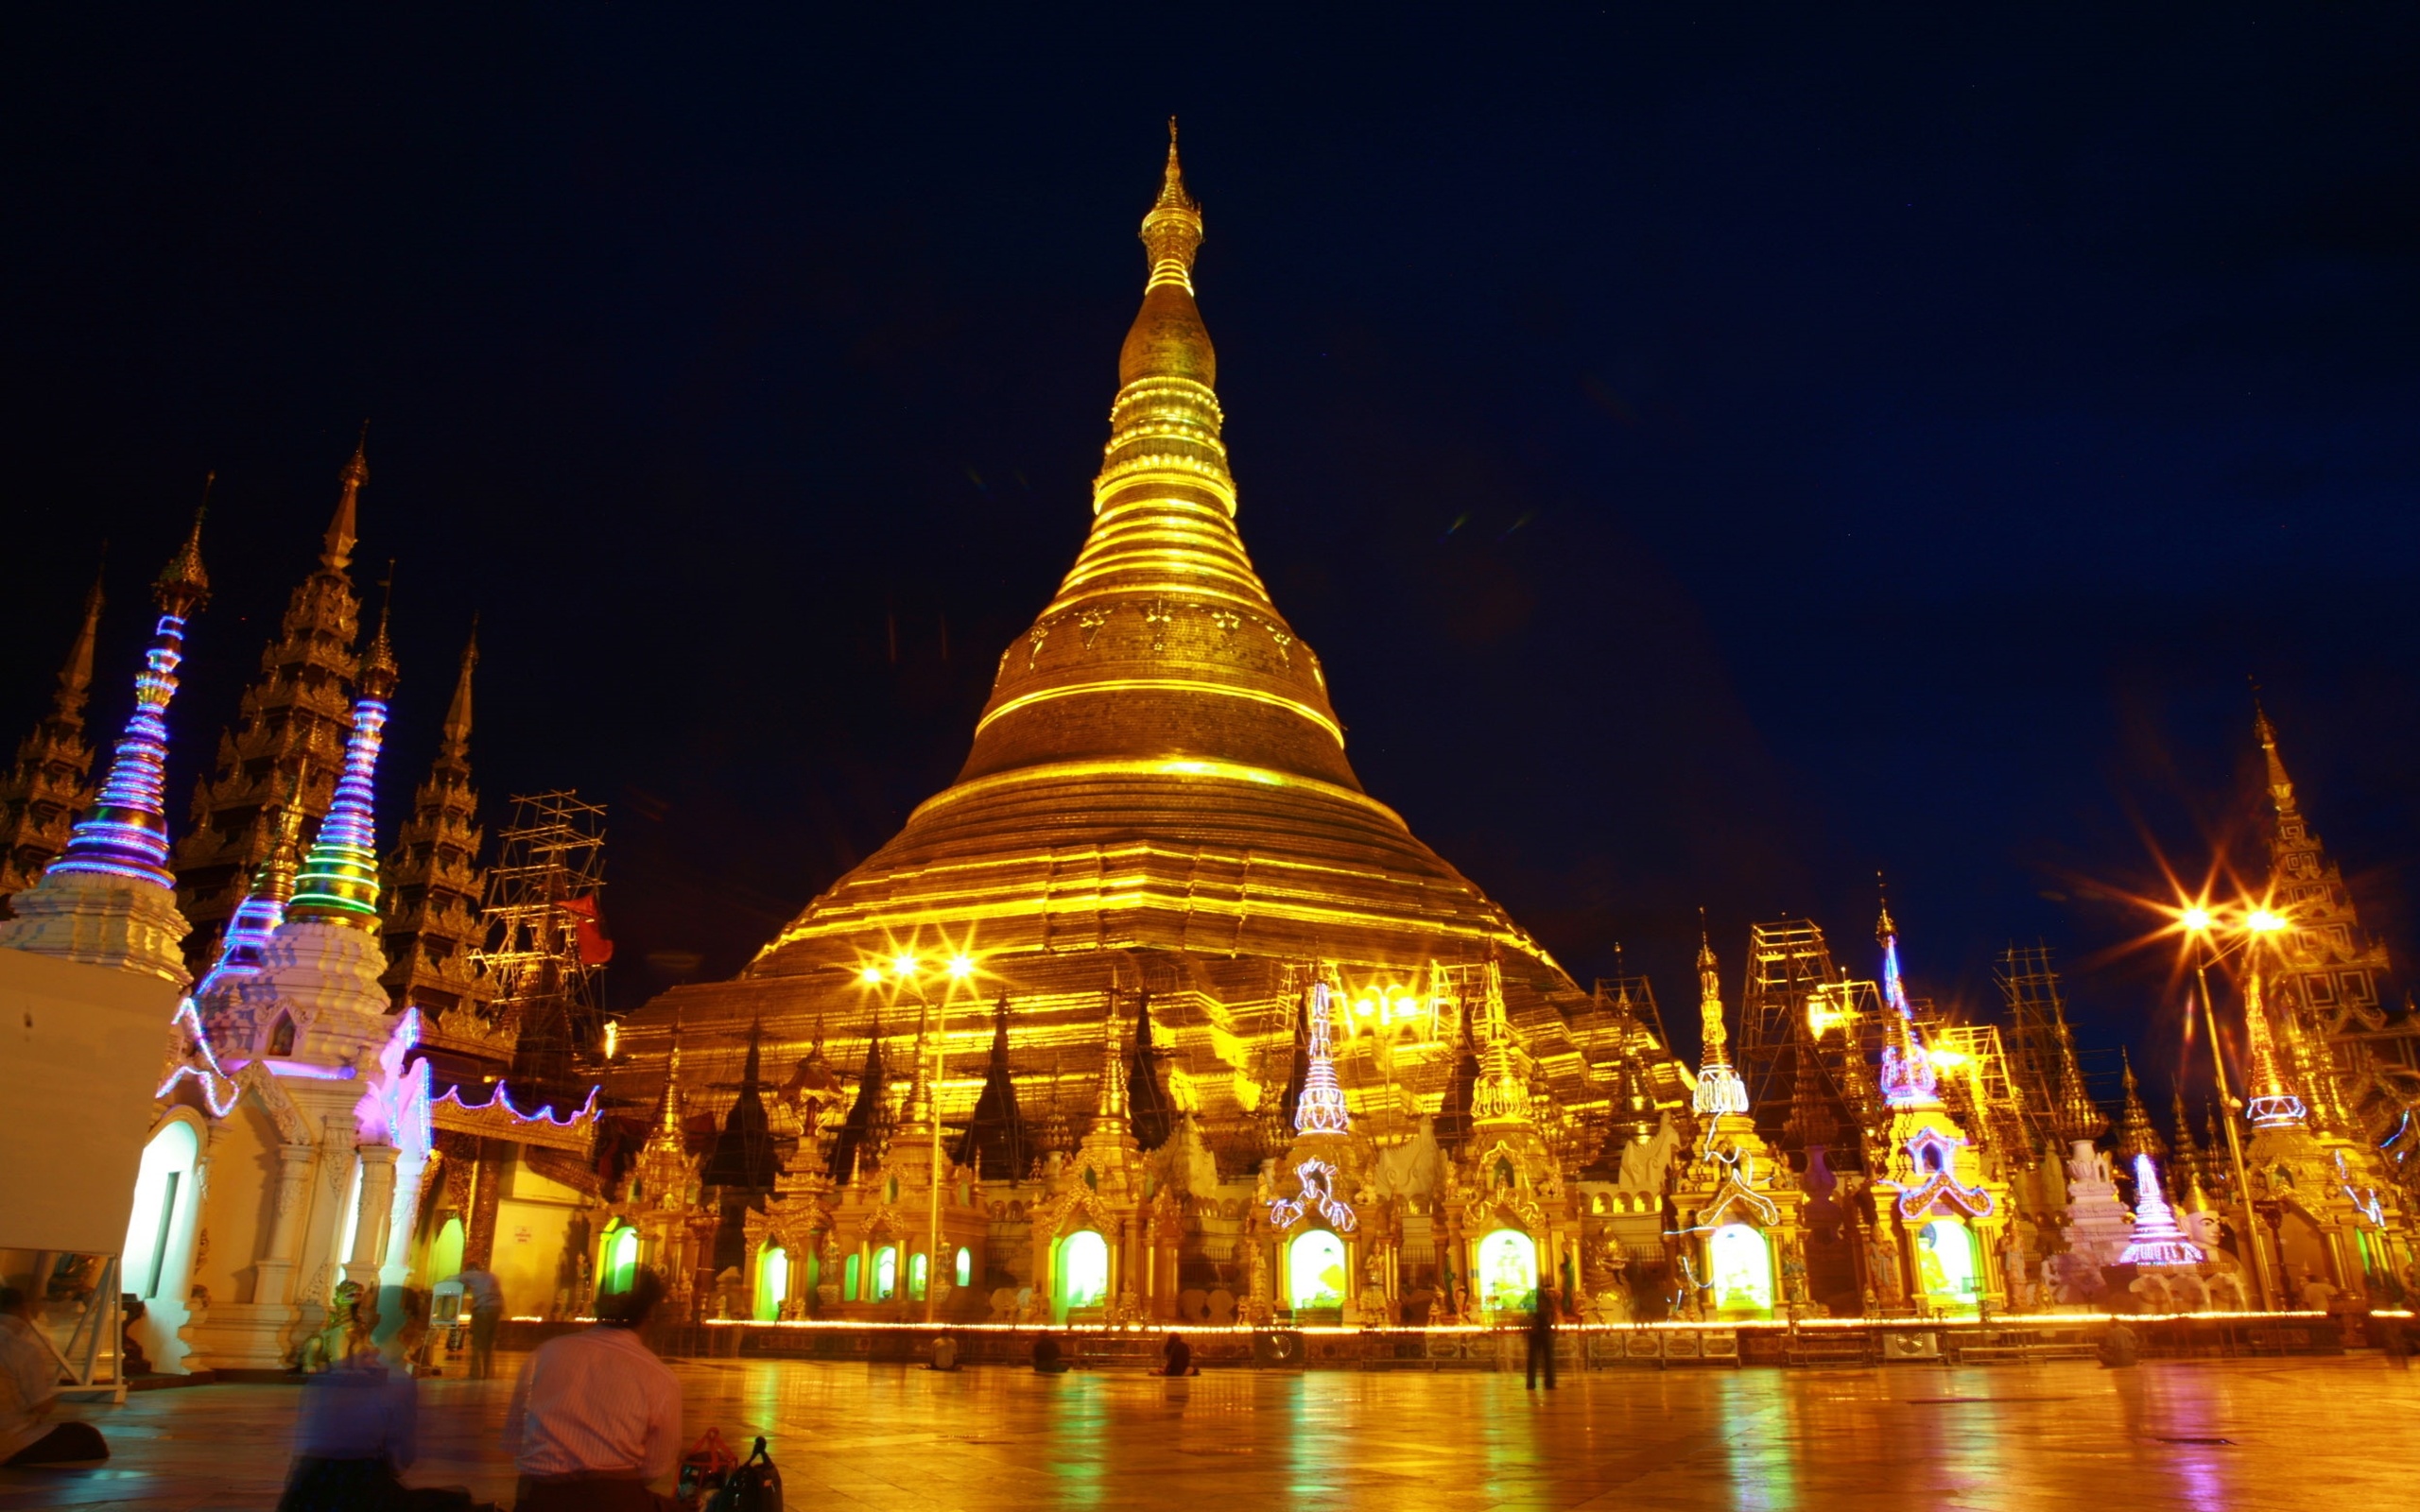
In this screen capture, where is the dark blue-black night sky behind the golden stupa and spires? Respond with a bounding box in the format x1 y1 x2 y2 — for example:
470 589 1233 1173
0 5 2420 1086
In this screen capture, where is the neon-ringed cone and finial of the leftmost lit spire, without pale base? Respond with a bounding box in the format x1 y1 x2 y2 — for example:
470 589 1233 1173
51 500 217 890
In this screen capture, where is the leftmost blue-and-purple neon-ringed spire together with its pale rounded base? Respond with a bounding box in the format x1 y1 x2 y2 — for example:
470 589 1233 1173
0 506 211 987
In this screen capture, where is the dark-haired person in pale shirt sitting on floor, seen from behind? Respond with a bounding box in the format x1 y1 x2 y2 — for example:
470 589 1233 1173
506 1267 680 1512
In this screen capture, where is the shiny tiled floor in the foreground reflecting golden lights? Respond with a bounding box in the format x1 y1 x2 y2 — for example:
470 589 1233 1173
0 1355 2420 1512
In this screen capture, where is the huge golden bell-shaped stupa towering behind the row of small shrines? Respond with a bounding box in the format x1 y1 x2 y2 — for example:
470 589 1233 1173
610 126 1682 1163
